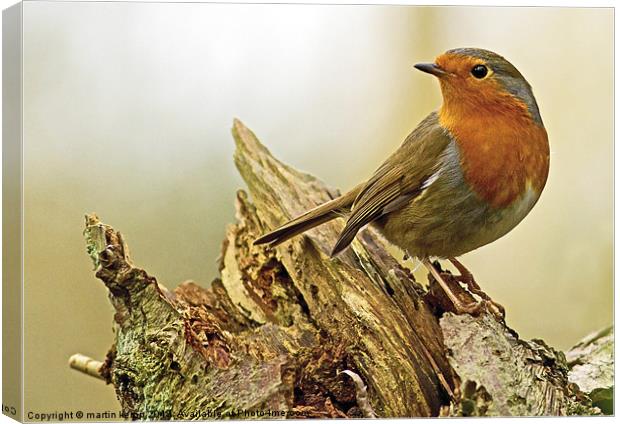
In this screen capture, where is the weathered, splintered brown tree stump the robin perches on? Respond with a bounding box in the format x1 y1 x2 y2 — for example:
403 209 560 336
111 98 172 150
72 121 612 419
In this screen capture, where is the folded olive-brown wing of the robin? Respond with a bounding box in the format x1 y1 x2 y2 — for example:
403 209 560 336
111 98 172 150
332 112 451 256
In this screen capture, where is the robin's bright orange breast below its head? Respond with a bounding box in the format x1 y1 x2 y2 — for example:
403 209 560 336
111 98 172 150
439 99 549 209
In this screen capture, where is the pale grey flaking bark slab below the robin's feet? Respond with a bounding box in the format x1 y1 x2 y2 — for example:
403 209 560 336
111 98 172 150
441 314 597 416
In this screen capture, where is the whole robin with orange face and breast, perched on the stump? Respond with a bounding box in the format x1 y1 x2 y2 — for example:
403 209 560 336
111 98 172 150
255 48 549 316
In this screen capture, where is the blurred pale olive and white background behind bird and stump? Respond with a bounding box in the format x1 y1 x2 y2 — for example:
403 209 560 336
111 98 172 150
24 2 613 418
